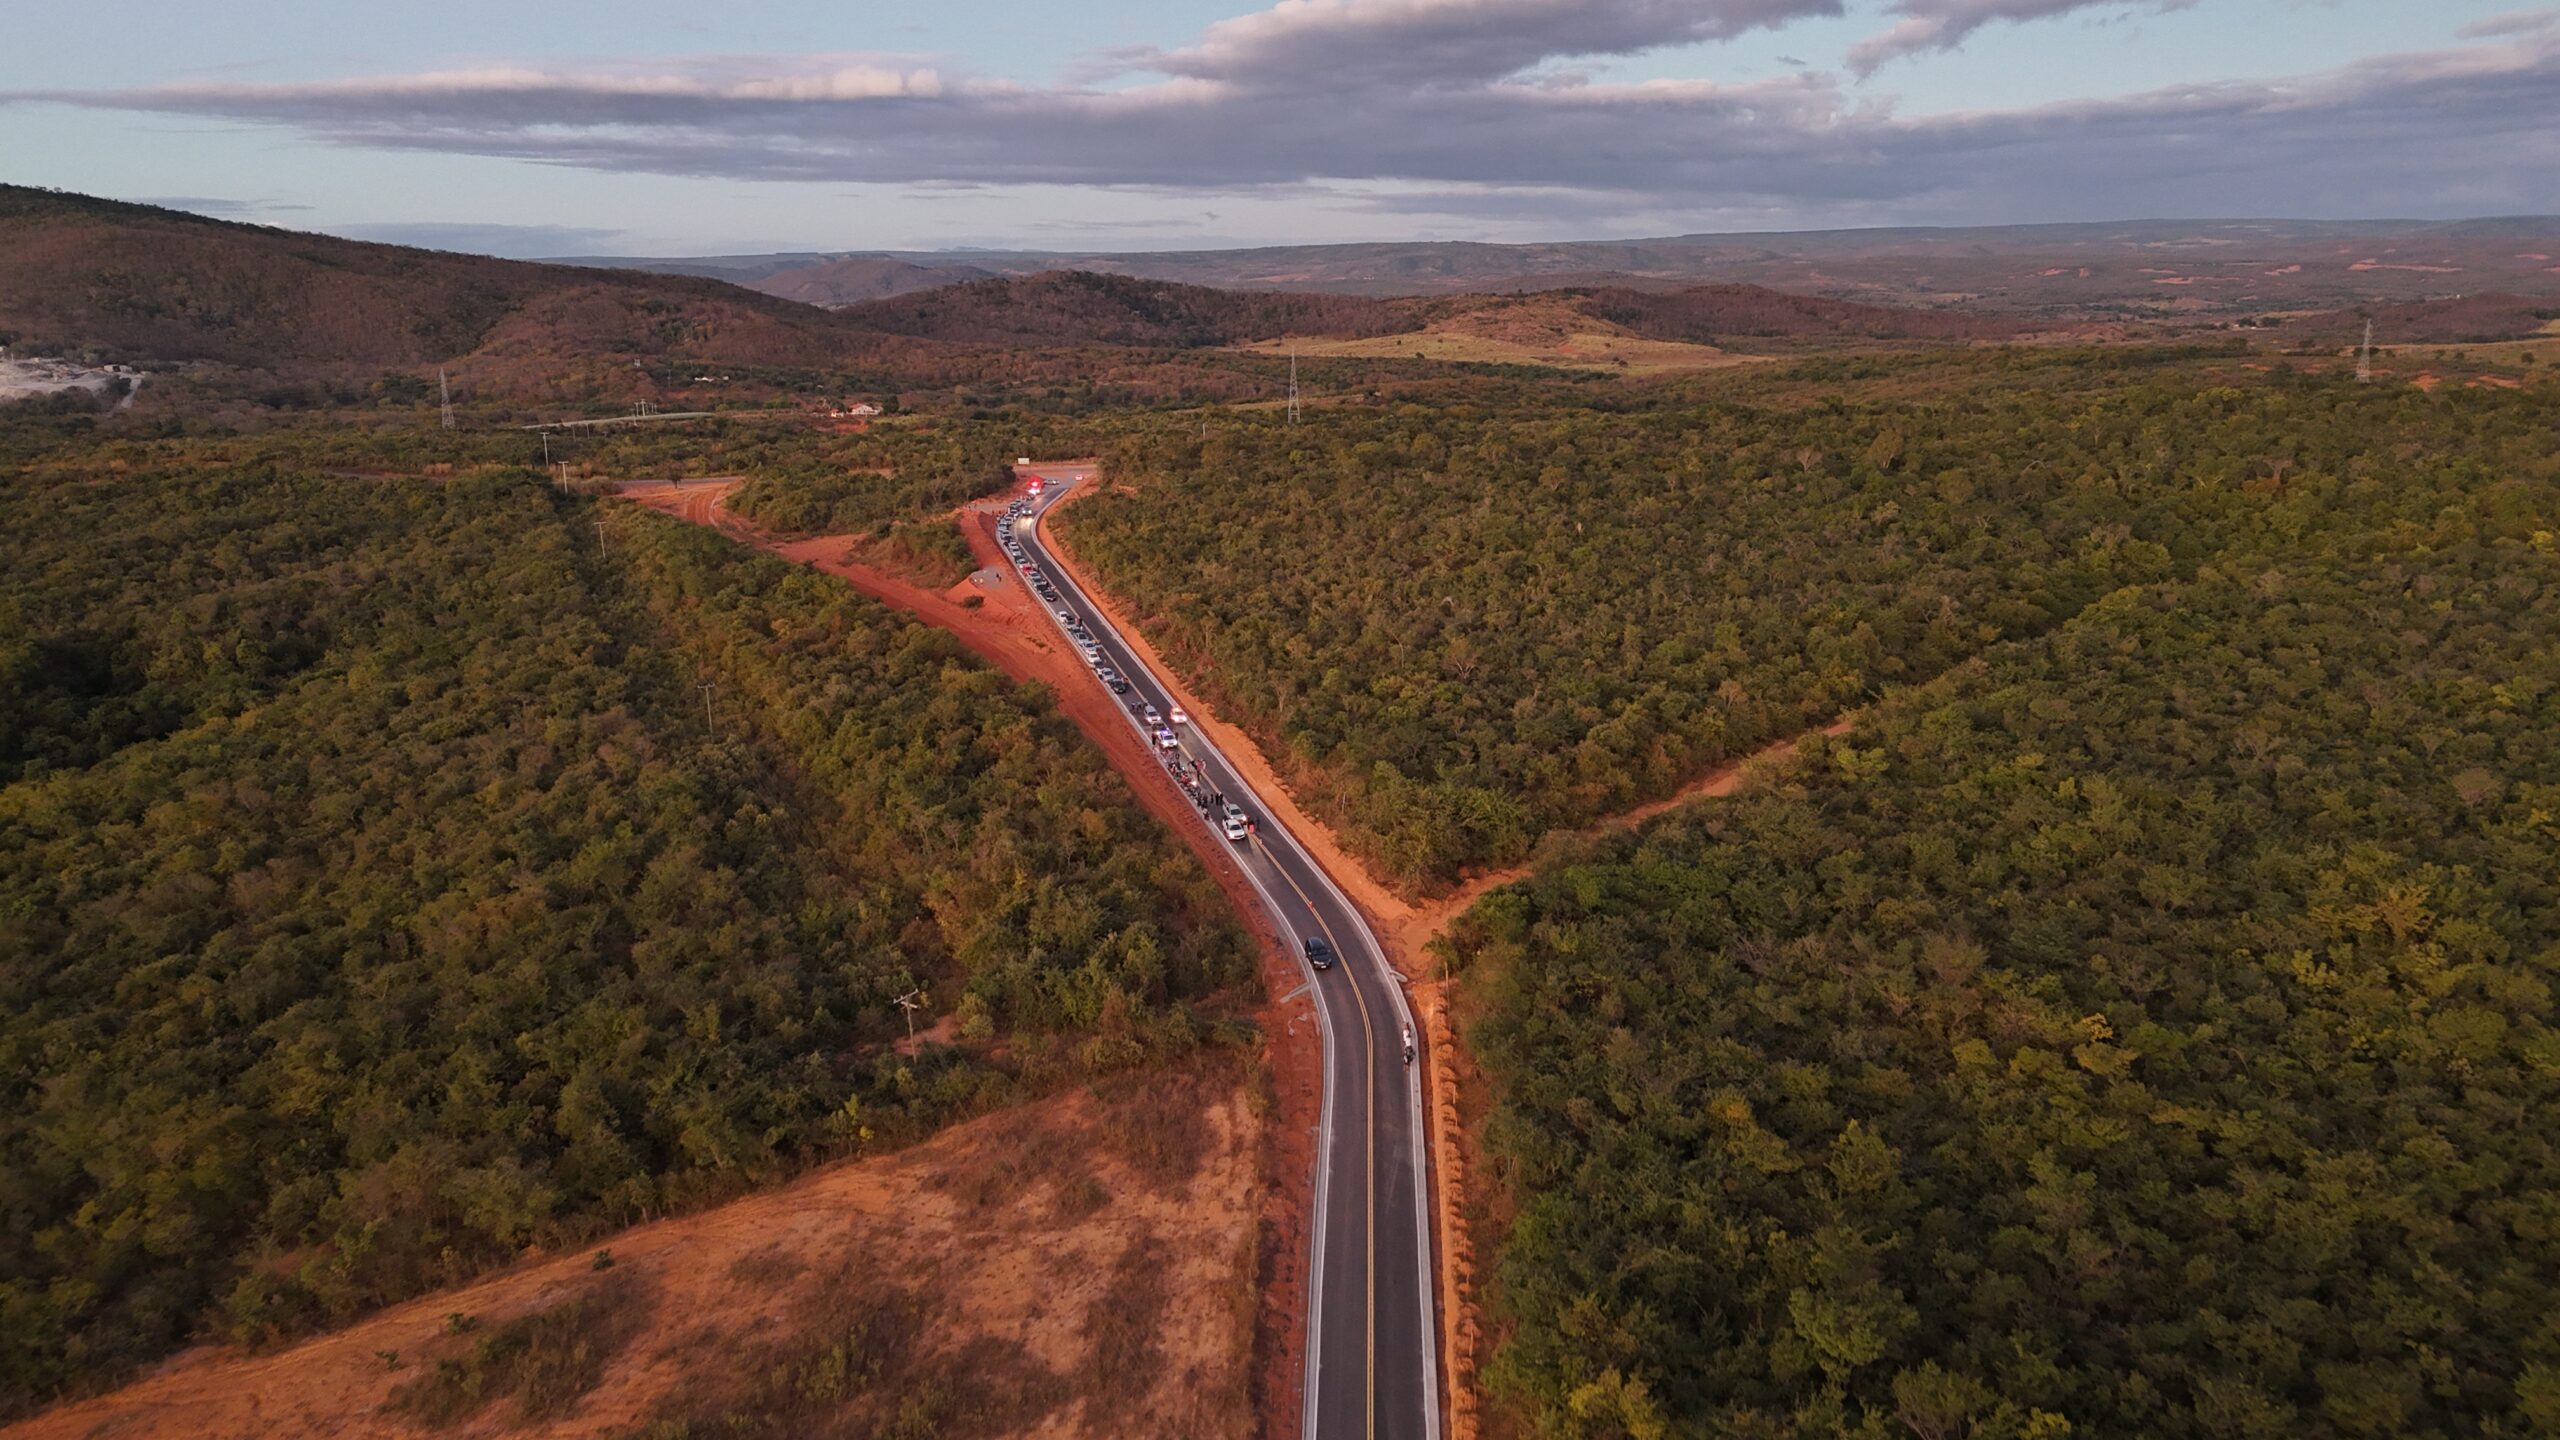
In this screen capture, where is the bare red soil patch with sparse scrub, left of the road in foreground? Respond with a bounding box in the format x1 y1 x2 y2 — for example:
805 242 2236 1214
5 1068 1267 1440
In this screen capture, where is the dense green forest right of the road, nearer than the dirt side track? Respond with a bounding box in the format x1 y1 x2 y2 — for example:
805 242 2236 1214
1454 384 2560 1440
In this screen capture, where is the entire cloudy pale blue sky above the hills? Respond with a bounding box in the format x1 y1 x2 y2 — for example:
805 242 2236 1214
0 0 2560 256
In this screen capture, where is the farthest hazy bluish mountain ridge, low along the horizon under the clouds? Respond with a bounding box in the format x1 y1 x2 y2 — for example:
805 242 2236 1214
561 215 2560 318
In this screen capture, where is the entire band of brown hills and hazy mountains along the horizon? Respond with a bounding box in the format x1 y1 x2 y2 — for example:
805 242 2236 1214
0 184 2560 397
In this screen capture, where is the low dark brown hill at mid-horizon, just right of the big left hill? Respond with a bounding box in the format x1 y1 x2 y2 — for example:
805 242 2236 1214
837 272 1413 348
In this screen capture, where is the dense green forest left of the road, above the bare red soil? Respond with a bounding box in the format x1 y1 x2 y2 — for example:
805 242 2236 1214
0 423 1244 1409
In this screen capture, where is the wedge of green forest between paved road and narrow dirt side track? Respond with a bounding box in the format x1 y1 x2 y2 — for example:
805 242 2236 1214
1060 356 2540 889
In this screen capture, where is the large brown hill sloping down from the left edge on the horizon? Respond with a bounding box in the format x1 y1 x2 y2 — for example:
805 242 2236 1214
0 187 921 369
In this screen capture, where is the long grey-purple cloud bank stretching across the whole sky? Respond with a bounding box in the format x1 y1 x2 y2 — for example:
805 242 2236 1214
0 0 2560 231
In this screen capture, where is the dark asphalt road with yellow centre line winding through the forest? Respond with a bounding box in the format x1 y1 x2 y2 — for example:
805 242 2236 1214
1014 466 1439 1440
